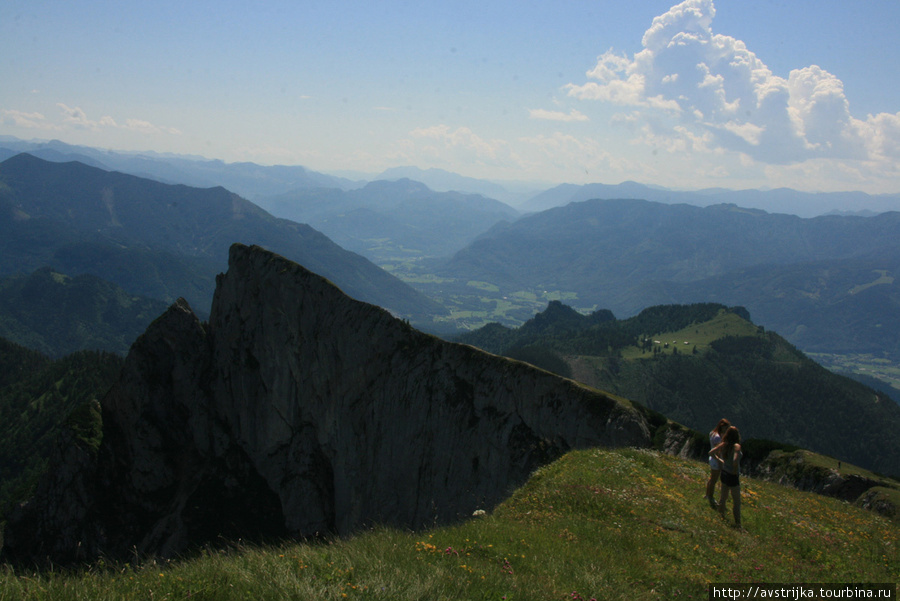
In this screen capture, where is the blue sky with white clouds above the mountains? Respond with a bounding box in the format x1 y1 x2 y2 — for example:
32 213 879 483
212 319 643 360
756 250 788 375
0 0 900 193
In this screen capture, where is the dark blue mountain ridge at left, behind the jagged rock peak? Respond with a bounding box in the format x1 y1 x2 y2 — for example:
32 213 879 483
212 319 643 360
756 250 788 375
0 154 441 326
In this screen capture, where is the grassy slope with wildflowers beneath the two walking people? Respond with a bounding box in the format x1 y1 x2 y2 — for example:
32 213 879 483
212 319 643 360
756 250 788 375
0 449 900 601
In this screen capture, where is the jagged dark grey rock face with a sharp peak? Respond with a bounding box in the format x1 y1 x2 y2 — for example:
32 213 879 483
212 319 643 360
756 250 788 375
4 245 650 561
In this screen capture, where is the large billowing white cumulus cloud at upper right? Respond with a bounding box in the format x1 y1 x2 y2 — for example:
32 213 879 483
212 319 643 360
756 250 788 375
565 0 900 165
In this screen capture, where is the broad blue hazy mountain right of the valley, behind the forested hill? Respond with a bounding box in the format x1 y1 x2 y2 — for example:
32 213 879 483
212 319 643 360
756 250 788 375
435 200 900 357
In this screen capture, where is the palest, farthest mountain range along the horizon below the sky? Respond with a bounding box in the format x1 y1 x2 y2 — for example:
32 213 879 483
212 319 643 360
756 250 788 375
7 136 900 217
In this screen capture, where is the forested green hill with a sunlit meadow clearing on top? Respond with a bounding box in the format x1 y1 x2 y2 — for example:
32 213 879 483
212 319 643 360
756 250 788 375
459 302 900 475
